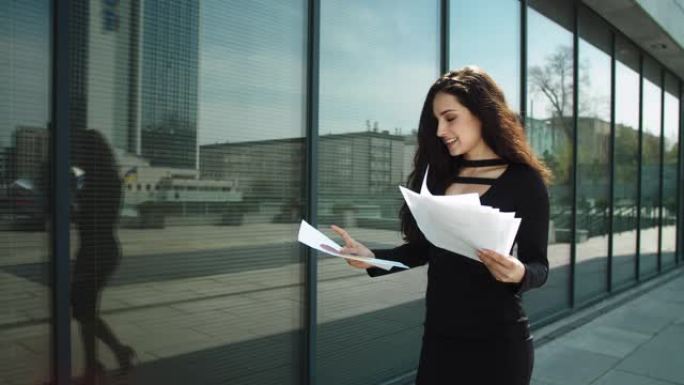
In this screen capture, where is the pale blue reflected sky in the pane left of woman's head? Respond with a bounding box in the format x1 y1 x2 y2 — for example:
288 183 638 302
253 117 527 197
319 0 439 135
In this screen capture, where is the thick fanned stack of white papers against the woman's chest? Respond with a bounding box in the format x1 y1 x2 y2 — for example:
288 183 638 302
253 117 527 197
399 167 520 261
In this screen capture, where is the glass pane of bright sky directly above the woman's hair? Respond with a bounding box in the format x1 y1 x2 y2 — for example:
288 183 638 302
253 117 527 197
449 0 520 111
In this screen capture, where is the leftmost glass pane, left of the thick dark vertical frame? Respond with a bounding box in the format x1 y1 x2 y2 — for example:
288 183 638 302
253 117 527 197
0 0 52 385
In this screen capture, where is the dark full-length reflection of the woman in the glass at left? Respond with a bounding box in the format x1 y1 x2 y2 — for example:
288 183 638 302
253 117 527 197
71 129 135 385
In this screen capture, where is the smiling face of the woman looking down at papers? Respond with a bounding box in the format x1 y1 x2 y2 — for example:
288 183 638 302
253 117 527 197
432 92 482 156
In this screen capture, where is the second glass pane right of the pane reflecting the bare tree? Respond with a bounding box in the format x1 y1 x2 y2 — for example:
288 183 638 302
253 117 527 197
612 38 639 288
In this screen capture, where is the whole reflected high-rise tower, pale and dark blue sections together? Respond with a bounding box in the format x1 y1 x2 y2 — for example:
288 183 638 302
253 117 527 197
79 0 199 168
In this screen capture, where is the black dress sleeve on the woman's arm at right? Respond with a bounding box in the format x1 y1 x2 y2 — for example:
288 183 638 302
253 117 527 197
513 168 549 294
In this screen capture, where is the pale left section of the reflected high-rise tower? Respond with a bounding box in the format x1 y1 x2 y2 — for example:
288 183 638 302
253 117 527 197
84 0 139 152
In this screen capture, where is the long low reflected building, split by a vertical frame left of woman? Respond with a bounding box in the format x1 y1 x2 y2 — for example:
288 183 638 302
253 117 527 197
200 131 408 200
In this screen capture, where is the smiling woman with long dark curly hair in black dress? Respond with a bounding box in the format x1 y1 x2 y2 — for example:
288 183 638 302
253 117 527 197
332 66 551 385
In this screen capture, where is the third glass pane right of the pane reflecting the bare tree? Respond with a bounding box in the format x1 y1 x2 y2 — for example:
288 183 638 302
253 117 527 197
639 59 662 279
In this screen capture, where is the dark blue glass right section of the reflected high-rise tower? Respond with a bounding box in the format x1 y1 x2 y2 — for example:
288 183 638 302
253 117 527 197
136 0 200 168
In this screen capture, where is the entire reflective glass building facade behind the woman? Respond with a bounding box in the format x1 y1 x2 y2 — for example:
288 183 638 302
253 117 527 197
0 0 684 385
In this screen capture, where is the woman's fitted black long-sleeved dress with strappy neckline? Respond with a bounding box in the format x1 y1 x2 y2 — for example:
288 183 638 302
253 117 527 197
367 160 549 385
